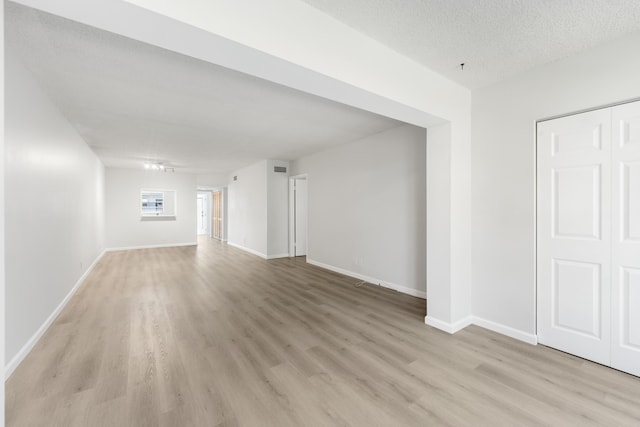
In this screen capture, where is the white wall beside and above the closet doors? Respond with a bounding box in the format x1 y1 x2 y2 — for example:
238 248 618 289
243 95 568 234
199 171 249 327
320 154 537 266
472 33 640 338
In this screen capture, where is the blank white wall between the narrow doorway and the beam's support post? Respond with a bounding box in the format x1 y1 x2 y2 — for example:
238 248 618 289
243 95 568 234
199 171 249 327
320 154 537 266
291 125 426 297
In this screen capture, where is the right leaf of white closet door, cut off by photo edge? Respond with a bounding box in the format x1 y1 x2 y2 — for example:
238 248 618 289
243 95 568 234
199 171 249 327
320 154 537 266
611 102 640 375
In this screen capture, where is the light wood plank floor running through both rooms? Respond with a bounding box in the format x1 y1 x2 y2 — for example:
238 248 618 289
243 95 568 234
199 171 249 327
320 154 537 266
6 239 640 426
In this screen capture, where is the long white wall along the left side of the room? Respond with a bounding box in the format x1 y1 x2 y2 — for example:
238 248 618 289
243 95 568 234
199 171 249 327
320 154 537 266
4 49 104 371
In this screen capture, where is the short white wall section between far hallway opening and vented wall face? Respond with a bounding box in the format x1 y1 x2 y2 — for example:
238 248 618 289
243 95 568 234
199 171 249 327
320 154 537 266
227 160 268 258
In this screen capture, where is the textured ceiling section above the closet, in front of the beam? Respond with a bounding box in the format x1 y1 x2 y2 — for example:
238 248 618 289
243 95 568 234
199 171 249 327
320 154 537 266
301 0 640 89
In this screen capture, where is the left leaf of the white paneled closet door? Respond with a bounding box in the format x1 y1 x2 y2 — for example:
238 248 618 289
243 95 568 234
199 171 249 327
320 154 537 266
537 109 611 365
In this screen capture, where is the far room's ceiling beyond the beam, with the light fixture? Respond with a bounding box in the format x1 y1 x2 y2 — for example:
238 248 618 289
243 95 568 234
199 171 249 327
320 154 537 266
5 3 401 173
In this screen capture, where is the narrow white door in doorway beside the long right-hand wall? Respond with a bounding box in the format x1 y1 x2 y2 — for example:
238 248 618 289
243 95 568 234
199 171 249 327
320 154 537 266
289 174 309 257
